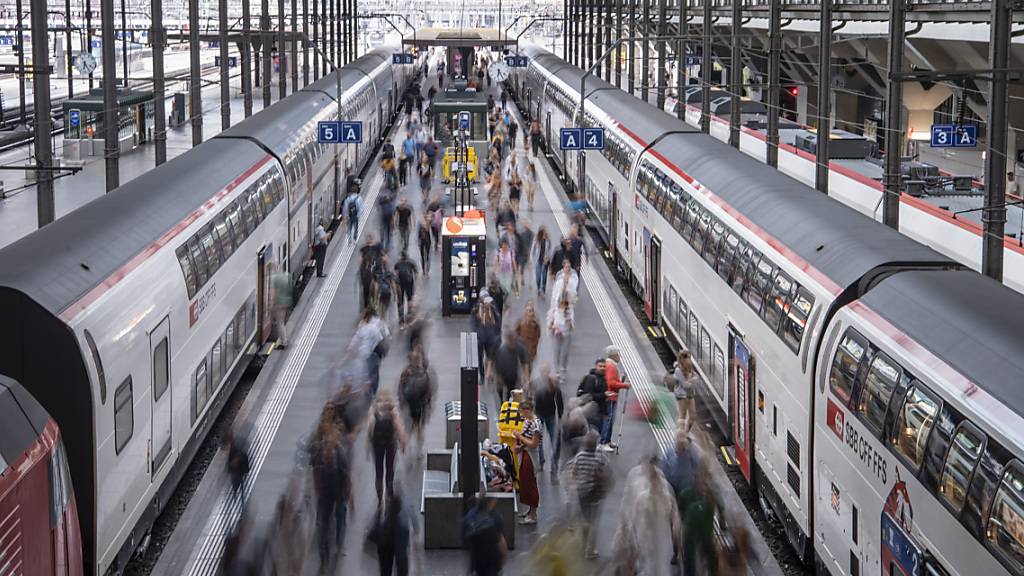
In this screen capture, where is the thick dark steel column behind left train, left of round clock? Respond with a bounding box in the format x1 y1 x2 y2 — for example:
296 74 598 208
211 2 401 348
29 0 54 223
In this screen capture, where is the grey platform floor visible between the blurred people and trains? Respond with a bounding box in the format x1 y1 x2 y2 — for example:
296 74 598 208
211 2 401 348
154 83 782 576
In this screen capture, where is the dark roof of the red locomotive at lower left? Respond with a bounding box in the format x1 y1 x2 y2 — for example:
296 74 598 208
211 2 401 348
0 374 50 471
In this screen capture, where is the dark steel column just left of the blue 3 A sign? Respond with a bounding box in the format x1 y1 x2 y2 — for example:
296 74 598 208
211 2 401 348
882 0 906 230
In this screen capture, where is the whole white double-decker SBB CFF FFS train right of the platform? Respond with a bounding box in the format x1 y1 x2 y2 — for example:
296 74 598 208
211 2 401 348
510 48 1024 576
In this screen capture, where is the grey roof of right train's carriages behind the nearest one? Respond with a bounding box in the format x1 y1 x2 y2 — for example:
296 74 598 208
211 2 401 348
529 47 954 288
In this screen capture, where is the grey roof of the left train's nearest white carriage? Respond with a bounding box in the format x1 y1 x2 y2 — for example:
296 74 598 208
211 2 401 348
0 138 266 315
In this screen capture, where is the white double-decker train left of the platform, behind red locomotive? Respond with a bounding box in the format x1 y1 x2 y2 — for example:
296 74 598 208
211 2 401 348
0 49 414 574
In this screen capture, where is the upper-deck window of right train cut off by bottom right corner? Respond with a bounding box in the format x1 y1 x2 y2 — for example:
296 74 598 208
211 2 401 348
985 460 1024 574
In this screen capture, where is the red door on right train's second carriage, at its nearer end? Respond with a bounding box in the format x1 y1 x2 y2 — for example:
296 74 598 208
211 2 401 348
729 324 757 482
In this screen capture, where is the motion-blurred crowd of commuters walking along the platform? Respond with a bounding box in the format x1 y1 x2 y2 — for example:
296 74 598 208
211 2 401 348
225 50 750 576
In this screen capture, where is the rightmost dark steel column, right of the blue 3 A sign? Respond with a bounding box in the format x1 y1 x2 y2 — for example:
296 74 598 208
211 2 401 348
981 0 1013 282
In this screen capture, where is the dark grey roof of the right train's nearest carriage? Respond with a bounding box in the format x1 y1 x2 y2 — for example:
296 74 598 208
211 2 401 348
860 271 1024 415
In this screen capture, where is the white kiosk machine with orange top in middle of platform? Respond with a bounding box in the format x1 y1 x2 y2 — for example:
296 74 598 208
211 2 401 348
441 210 487 316
